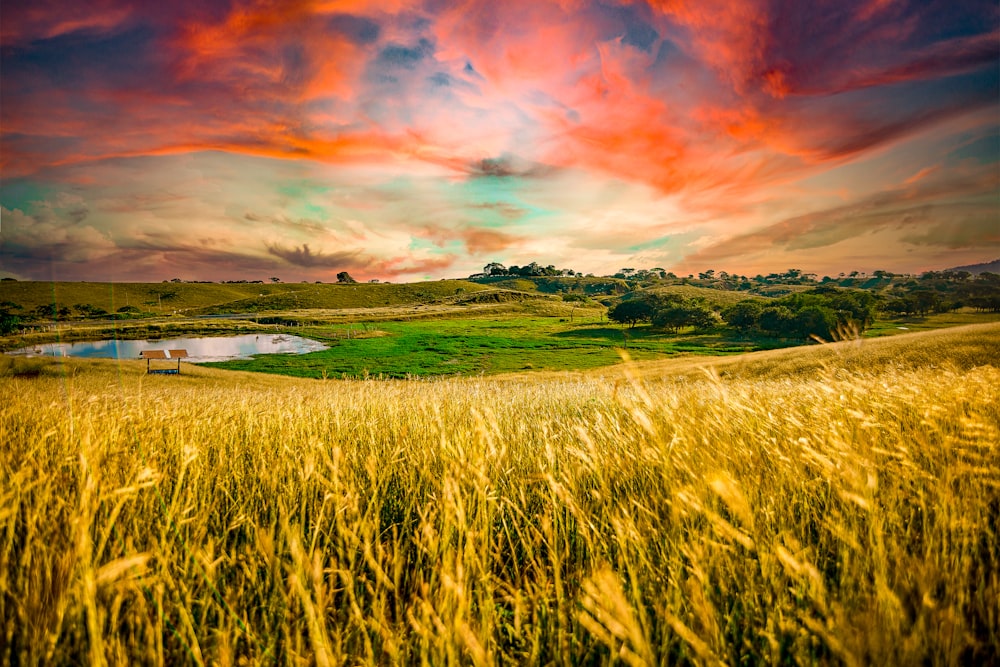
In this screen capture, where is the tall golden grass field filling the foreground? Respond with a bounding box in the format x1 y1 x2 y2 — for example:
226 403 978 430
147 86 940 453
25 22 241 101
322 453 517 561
0 325 1000 666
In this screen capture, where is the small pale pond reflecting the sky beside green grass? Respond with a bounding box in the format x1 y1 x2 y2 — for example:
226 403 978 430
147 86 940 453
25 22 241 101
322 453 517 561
7 334 326 362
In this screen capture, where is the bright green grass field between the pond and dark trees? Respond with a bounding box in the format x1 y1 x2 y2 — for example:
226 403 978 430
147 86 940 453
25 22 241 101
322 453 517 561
203 311 791 378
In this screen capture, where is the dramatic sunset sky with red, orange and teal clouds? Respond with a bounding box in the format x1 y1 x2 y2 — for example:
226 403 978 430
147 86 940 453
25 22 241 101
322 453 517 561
0 0 1000 282
